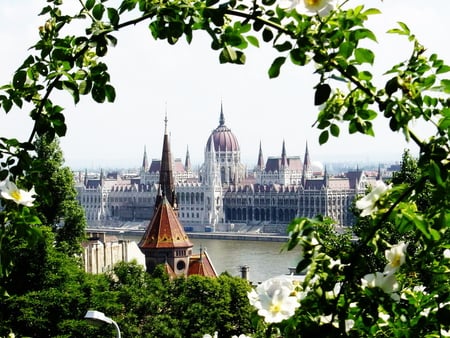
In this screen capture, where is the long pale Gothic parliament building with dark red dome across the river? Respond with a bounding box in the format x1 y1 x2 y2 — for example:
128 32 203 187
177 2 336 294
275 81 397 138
77 106 376 233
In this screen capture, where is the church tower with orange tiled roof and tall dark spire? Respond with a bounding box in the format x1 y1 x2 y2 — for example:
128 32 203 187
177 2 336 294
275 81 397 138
139 116 193 276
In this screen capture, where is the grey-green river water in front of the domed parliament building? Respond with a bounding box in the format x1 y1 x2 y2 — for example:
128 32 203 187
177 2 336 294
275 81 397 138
123 236 299 283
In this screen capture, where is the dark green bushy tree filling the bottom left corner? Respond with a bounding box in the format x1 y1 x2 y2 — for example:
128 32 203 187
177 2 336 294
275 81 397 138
0 227 103 337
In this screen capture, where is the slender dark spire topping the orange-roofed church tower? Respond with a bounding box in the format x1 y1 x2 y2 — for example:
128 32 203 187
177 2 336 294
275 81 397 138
155 112 177 210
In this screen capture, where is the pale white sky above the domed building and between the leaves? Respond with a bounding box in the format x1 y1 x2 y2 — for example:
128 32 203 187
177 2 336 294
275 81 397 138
0 0 450 169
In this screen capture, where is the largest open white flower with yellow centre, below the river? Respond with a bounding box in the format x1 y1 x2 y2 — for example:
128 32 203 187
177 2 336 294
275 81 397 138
248 277 300 323
